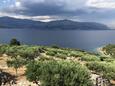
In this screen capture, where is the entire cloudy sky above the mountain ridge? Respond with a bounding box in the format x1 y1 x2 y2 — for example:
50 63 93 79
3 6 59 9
0 0 115 27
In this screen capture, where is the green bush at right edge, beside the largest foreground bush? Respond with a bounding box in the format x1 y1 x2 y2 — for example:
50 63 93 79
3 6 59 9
87 62 115 80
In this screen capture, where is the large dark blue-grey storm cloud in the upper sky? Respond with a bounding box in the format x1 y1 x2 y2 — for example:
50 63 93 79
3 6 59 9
6 0 87 16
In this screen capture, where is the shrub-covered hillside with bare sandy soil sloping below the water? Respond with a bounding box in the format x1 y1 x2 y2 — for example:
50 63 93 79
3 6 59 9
0 45 115 86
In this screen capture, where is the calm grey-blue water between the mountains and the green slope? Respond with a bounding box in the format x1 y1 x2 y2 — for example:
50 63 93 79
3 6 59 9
0 29 115 50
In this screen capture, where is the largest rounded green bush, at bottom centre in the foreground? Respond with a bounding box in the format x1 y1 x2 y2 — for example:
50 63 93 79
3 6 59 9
26 61 93 86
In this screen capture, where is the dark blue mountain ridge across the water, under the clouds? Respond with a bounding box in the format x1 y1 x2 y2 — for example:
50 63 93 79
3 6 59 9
0 17 110 30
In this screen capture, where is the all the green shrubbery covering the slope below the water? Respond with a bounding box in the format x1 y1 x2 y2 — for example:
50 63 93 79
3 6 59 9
0 41 115 86
